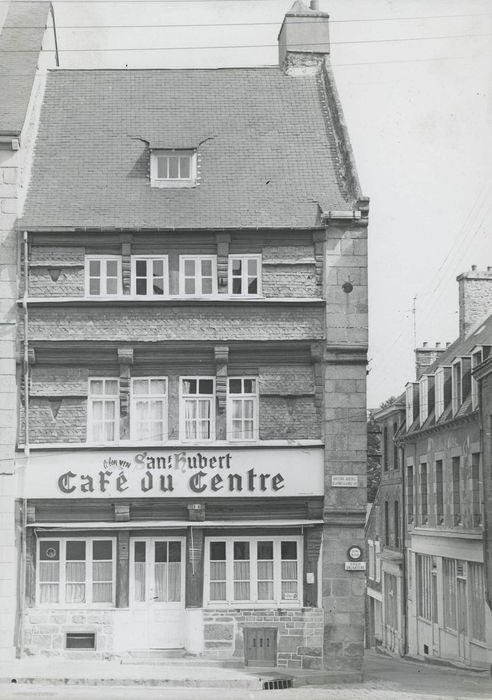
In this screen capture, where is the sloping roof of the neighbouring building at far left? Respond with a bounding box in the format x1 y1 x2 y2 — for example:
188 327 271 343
0 2 49 136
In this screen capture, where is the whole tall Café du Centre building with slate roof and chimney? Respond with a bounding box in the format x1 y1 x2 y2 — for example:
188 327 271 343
0 1 368 675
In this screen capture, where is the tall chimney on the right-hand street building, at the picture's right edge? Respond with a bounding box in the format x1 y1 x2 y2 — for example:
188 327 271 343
456 265 492 337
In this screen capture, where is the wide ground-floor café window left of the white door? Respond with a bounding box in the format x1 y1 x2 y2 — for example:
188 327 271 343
36 537 116 606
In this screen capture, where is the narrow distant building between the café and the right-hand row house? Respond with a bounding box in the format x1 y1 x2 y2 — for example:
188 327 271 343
366 397 405 655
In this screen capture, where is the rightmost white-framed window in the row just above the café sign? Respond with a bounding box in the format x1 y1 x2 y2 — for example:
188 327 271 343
227 377 258 440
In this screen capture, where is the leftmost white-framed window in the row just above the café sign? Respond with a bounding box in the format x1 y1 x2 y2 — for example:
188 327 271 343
87 377 120 442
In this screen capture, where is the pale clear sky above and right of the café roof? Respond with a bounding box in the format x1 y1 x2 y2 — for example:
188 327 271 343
0 0 492 407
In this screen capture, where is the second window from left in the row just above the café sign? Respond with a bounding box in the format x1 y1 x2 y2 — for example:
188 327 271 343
130 377 167 442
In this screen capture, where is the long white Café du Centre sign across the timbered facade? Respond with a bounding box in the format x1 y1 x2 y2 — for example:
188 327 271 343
17 447 324 499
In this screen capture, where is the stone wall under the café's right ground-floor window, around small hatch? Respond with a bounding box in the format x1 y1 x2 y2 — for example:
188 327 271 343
203 608 323 669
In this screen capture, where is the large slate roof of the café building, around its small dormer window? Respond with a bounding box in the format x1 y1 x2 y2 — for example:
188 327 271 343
20 67 358 230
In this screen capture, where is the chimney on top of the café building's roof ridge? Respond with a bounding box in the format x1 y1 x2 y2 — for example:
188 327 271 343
278 0 330 76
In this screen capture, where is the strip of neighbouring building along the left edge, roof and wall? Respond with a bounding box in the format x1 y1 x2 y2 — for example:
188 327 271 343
0 2 49 659
